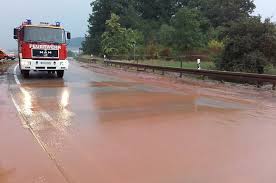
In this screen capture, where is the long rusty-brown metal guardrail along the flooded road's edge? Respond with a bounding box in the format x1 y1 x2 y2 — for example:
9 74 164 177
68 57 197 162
104 60 276 90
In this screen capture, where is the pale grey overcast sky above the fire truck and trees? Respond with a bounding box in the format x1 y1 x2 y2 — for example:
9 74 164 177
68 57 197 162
0 0 276 49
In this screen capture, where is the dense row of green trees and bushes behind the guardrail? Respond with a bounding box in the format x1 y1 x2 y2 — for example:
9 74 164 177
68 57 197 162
82 0 276 73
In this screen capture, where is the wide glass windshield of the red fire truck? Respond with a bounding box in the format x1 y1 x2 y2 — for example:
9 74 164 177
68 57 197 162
24 27 66 44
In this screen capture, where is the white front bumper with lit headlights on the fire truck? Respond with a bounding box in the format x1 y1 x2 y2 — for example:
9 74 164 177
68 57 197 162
20 59 69 71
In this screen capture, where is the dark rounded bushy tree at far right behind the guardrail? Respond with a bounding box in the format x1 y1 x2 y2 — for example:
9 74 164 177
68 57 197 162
216 17 276 74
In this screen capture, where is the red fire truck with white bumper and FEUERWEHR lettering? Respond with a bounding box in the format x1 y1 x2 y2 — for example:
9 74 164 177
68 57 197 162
14 20 71 78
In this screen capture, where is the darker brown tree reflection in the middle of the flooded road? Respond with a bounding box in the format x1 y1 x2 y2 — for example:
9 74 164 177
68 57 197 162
89 89 248 122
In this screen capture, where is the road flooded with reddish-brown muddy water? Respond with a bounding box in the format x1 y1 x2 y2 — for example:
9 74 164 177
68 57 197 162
0 63 276 183
